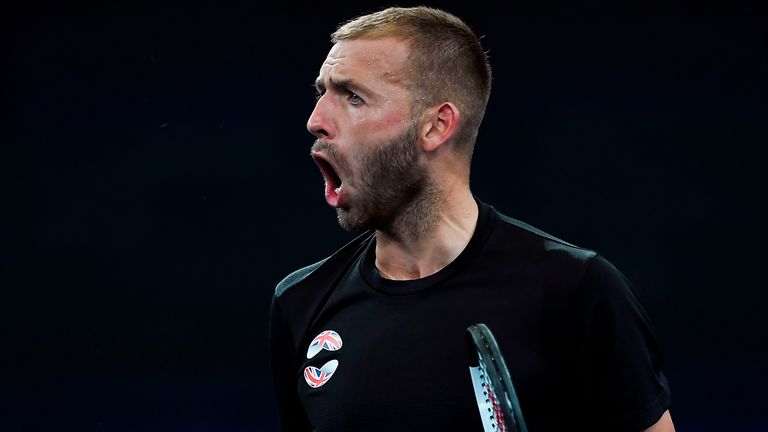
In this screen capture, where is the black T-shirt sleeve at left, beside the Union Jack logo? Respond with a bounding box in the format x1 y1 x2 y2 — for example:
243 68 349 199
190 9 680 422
269 297 312 432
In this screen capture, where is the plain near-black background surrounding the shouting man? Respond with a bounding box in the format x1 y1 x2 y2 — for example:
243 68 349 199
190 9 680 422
0 2 768 431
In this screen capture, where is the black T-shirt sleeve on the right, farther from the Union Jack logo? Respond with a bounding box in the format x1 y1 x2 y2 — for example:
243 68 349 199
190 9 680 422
581 255 671 431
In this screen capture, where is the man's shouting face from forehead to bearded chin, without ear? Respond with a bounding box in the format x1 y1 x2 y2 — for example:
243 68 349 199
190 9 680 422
307 39 430 229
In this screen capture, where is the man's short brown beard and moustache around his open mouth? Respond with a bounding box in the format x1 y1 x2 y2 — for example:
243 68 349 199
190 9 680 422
315 124 440 238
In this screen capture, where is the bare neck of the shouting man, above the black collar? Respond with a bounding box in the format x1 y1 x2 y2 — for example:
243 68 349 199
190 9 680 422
376 184 478 280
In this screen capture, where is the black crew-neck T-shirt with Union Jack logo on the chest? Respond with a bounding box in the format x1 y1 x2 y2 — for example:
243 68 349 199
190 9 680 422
270 203 670 431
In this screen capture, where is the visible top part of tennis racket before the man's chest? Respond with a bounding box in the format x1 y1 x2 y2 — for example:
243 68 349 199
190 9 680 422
466 323 528 432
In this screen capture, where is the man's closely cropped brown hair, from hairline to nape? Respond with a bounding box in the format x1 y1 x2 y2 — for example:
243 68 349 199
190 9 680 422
331 6 491 157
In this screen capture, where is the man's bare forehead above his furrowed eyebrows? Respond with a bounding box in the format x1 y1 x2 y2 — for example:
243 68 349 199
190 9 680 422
319 38 409 85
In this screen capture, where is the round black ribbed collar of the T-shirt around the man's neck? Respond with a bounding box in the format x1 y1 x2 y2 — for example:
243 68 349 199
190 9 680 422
358 198 494 295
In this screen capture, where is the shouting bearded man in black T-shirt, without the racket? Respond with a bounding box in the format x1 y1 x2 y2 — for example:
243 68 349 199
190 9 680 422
270 7 674 431
